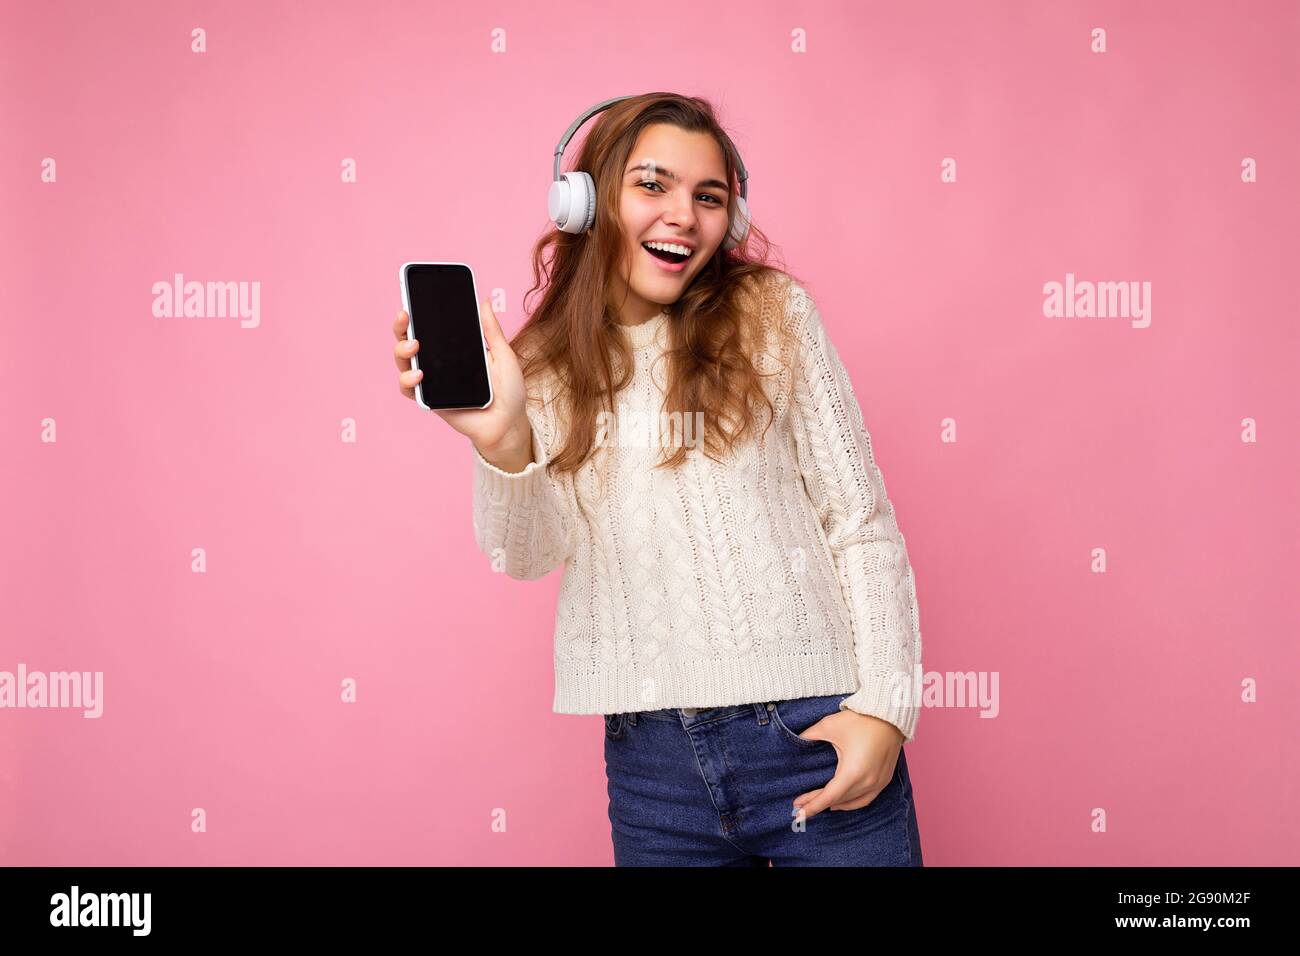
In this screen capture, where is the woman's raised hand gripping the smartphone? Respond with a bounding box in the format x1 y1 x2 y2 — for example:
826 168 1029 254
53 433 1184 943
393 299 533 472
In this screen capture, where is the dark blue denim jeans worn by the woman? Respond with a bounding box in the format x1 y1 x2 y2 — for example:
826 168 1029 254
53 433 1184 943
605 693 923 866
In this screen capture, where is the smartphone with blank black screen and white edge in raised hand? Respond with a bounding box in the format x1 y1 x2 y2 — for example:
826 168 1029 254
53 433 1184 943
400 263 491 411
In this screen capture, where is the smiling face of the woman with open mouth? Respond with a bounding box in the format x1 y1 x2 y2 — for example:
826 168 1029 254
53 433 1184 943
611 124 731 325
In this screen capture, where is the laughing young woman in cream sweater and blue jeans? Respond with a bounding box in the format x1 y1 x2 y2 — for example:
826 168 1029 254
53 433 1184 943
393 92 922 866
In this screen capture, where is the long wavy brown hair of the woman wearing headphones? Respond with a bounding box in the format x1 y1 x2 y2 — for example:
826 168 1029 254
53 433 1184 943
510 92 793 472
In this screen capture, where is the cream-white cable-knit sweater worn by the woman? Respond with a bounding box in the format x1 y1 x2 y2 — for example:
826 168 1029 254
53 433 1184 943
471 272 920 743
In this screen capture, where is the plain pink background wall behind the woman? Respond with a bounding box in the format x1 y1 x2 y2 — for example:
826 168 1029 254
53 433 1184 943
0 1 1300 865
